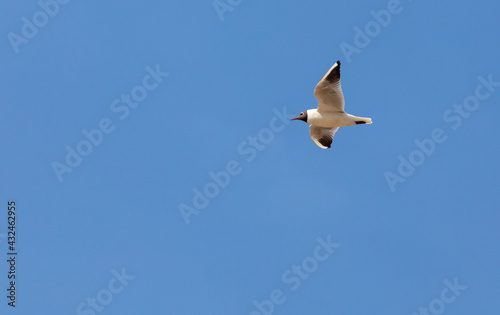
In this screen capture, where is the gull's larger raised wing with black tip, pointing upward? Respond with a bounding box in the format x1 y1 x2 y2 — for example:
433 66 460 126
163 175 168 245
314 61 344 112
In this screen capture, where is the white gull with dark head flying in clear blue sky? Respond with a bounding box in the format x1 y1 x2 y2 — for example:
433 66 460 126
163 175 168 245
290 61 372 149
